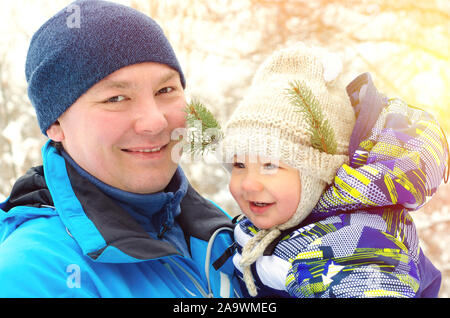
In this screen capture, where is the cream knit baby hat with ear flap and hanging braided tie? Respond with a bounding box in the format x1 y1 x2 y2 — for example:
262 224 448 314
222 43 355 296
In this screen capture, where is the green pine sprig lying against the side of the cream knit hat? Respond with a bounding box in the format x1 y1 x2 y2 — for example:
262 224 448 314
288 81 337 154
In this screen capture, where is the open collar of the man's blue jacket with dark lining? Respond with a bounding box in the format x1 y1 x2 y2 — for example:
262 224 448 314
42 142 233 262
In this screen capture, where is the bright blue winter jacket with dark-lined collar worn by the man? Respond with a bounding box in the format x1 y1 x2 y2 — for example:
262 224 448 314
0 142 240 297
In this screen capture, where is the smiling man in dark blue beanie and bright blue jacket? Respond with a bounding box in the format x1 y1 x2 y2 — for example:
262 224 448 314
0 0 240 297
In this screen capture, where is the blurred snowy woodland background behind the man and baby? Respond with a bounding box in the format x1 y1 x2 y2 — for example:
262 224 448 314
0 0 450 297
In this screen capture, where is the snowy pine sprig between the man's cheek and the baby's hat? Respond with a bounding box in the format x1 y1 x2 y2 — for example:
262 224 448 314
185 100 222 154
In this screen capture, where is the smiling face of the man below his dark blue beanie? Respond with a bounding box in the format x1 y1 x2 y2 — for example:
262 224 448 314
47 62 186 193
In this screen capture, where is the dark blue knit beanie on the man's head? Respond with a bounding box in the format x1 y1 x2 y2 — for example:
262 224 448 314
25 0 186 135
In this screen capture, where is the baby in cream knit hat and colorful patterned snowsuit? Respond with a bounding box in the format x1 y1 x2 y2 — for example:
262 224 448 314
222 44 448 297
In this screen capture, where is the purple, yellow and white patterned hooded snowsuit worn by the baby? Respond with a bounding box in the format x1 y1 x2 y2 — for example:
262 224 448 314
233 74 448 298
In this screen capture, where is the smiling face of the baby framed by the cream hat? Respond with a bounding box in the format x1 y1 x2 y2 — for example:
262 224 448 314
229 156 301 229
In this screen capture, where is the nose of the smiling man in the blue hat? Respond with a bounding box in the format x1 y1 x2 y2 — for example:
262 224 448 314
134 97 168 135
